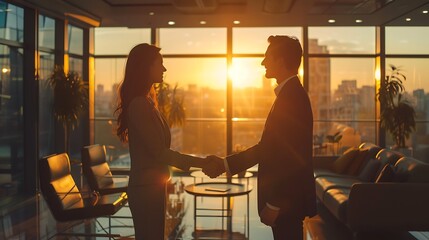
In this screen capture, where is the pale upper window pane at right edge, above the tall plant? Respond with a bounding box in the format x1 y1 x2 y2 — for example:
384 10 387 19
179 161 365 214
386 27 429 54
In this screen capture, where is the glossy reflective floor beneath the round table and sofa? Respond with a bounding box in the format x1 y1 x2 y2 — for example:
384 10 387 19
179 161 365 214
94 176 429 240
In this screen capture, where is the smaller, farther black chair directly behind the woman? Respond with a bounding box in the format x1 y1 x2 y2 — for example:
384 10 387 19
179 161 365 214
82 144 129 195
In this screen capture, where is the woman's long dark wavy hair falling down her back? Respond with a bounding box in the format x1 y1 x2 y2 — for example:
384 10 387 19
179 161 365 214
115 43 161 142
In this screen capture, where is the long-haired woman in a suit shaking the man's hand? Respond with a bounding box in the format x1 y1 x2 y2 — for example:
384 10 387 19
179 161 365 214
115 44 207 240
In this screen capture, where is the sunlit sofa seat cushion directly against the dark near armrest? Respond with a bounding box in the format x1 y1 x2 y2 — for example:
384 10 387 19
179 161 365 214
323 188 350 223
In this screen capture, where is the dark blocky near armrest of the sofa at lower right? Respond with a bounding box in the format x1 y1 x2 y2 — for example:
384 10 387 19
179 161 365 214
347 183 429 231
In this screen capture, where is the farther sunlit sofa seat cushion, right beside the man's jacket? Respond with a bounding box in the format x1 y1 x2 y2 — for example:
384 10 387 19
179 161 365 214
315 176 362 201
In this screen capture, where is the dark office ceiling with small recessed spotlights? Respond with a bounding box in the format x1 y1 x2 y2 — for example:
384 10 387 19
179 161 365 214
26 0 429 28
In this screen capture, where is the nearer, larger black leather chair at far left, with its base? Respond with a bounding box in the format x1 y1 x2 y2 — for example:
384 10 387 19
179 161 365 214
39 153 127 239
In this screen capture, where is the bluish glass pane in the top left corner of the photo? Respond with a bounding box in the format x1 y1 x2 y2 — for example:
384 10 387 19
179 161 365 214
0 1 24 43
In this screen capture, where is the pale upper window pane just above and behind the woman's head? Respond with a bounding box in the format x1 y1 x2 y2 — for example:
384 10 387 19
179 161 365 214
94 27 150 55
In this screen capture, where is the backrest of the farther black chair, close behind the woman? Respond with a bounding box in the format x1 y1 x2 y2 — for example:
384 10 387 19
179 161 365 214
82 144 113 191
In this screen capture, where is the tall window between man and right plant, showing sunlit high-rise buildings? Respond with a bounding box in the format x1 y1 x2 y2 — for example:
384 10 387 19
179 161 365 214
308 27 377 155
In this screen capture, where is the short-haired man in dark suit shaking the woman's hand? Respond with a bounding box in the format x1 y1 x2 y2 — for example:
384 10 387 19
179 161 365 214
203 36 316 240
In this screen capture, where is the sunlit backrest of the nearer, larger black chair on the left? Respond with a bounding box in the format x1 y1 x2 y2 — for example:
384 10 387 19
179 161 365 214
39 153 83 220
